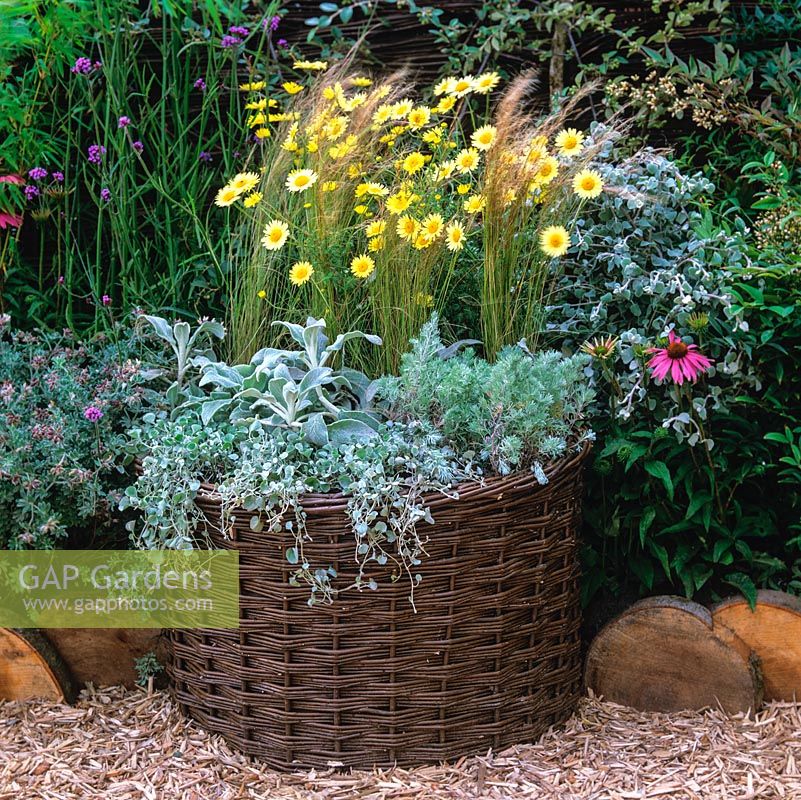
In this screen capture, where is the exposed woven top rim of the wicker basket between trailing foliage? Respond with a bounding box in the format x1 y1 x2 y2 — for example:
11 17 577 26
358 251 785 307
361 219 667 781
195 440 592 512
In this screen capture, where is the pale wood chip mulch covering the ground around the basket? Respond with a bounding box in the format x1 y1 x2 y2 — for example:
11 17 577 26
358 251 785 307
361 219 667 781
0 688 801 800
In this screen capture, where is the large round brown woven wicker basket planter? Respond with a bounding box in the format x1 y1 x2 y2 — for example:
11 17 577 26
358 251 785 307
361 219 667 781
170 444 586 770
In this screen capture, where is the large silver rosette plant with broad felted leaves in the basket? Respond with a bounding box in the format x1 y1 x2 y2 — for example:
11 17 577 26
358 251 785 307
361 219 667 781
185 317 381 446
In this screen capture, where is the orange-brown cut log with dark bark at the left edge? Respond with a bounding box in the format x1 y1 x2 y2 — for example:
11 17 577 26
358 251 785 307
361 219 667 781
0 628 75 702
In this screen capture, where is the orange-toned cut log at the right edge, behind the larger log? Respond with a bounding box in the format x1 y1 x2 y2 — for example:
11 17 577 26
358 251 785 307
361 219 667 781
712 589 801 701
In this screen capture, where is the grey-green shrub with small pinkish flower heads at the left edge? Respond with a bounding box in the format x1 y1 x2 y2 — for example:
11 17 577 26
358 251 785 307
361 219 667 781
0 317 144 549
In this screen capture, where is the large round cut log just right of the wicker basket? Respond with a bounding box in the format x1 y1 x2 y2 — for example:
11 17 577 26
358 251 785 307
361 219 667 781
585 597 762 713
